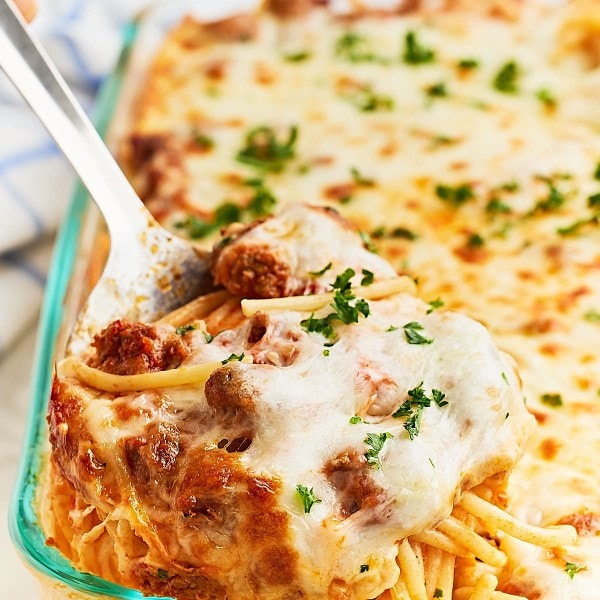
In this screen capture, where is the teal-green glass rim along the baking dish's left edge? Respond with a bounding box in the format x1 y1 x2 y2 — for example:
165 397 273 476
8 16 169 600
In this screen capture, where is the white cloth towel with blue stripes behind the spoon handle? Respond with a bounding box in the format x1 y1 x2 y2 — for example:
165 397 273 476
0 0 149 356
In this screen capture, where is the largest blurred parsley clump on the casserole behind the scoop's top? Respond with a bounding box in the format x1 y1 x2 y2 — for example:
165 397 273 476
236 125 298 173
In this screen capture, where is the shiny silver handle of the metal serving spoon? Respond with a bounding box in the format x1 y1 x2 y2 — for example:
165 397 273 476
0 0 152 240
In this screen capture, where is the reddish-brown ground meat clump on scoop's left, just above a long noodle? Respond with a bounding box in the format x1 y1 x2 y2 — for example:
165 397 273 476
88 320 190 375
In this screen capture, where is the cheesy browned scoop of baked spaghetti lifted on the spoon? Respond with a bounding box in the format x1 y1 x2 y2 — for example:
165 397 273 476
48 209 532 600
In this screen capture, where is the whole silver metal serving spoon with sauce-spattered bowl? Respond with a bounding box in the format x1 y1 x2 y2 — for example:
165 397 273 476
0 0 210 353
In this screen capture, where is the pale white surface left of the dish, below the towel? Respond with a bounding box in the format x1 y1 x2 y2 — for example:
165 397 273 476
0 323 38 600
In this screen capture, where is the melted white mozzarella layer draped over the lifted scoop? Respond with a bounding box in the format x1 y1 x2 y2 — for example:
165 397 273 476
75 294 532 598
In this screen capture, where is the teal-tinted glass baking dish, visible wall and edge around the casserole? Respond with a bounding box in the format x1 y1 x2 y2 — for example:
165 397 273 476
9 0 253 600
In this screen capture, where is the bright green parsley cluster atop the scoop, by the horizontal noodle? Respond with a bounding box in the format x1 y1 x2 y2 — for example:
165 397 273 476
300 268 371 339
